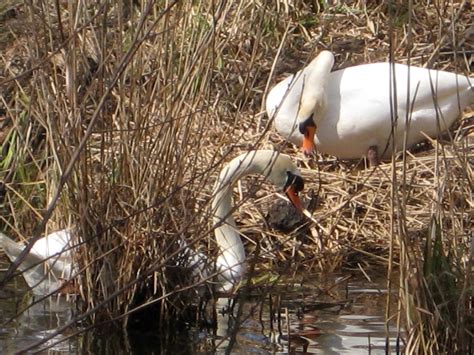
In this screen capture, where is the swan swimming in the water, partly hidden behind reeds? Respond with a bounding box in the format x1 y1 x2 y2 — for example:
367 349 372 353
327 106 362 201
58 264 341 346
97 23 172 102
0 150 304 295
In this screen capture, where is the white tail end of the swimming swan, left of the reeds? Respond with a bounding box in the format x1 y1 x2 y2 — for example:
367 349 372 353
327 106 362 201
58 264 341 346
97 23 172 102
0 229 73 295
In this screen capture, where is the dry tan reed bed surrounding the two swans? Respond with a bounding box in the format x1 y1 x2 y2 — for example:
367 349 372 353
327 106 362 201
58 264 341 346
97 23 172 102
0 0 474 353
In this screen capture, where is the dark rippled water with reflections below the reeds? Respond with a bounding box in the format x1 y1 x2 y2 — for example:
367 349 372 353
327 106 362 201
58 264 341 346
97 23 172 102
0 264 398 354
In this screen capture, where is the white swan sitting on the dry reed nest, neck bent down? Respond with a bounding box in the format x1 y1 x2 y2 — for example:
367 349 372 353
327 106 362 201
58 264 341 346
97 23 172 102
266 51 474 165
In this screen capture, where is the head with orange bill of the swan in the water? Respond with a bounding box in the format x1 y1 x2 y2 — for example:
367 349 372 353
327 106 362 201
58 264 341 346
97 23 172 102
268 152 304 212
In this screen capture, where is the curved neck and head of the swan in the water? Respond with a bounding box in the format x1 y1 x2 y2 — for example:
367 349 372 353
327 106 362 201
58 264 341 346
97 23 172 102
212 150 304 291
